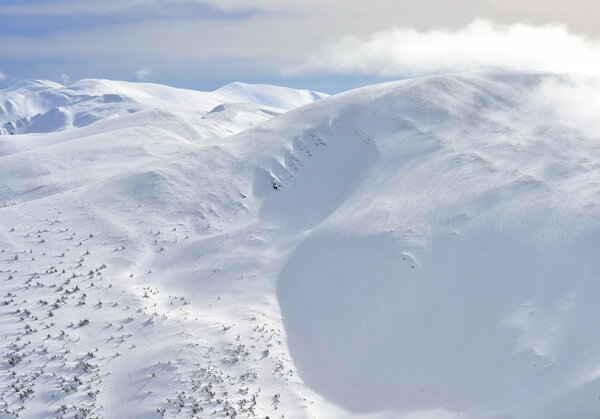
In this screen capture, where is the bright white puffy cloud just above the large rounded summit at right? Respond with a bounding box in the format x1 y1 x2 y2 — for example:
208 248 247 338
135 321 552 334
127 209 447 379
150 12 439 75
296 20 600 77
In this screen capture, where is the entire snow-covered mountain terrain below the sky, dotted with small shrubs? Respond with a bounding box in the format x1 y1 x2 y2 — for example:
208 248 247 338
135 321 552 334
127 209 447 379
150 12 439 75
0 72 600 419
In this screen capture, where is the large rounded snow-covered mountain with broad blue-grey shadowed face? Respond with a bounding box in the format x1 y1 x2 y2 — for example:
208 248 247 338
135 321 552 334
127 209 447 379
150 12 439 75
241 70 600 418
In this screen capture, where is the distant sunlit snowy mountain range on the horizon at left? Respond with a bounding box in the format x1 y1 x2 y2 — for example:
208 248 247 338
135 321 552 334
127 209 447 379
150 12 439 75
0 79 327 138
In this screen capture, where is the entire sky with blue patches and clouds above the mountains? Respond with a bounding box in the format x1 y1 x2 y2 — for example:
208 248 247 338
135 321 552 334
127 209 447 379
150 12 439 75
0 0 600 93
